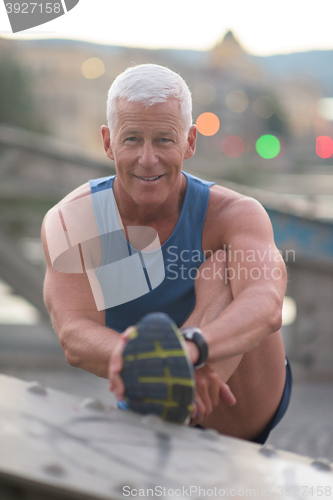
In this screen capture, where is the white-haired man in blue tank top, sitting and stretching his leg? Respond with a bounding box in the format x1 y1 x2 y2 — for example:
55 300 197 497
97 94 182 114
42 65 291 443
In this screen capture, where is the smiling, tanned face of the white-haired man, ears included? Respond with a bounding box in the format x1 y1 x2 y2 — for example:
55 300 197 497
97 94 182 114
102 99 196 207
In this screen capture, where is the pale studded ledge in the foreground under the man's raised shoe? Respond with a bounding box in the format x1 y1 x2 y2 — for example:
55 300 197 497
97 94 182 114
0 375 333 500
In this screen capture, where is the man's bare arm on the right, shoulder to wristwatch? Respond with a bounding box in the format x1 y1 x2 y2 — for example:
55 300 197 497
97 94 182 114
202 198 287 362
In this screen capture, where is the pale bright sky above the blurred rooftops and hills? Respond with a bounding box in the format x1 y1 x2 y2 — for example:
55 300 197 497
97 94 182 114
0 0 333 55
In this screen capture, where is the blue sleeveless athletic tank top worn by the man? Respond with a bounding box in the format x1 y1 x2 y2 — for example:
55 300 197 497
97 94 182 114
89 172 214 332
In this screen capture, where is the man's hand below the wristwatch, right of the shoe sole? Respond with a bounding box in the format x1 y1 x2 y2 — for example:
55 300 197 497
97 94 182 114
190 365 236 426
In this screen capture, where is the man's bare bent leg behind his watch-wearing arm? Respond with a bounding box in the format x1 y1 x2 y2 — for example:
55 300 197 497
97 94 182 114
184 250 286 439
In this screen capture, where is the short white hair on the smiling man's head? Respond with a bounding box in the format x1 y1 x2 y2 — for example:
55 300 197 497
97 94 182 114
106 64 192 134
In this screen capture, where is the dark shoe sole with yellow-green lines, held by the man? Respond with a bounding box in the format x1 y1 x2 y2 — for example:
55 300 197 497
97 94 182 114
120 313 195 423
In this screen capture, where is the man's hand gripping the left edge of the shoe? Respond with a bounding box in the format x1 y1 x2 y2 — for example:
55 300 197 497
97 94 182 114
109 326 135 401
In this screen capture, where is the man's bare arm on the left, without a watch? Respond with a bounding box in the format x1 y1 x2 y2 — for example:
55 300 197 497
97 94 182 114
42 187 120 378
